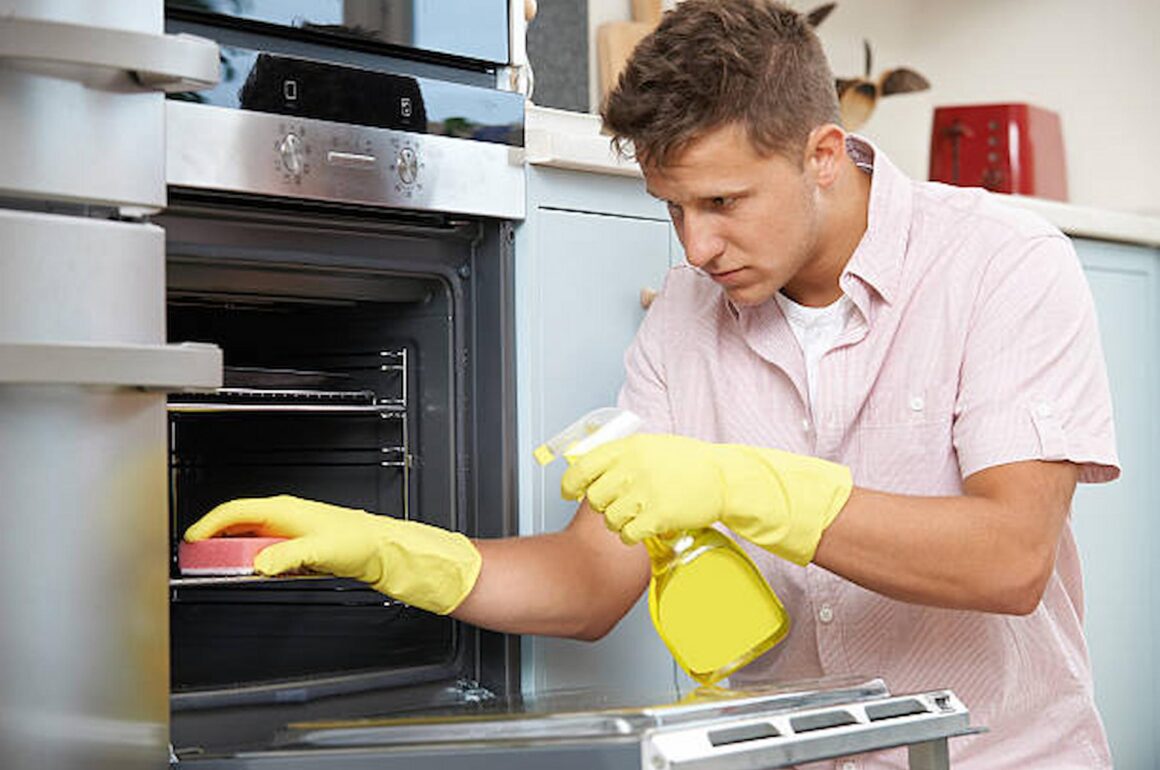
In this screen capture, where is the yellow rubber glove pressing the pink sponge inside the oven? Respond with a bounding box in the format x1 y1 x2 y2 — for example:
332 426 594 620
186 495 483 615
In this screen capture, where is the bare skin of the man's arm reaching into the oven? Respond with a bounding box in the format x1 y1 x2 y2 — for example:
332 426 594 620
452 502 650 640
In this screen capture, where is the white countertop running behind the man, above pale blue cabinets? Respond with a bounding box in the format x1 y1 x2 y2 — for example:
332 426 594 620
524 104 1160 246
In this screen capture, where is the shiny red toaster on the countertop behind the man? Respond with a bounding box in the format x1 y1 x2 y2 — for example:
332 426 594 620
930 104 1067 201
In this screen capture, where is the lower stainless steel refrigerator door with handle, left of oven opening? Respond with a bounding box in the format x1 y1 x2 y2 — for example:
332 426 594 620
0 210 220 770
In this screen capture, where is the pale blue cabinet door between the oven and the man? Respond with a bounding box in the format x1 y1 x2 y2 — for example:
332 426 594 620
516 208 673 695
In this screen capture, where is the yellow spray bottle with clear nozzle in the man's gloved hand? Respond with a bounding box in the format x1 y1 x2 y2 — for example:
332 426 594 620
535 407 790 684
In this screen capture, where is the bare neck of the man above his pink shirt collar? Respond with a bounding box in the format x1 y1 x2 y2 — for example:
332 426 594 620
782 154 870 307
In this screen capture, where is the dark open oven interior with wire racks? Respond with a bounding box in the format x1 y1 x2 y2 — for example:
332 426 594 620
160 196 516 751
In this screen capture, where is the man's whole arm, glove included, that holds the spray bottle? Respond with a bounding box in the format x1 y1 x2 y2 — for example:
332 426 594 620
561 435 1079 613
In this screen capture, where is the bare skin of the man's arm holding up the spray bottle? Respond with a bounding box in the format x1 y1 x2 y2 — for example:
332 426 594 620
814 460 1079 615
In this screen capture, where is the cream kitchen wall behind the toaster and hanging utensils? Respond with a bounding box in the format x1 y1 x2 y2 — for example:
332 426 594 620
588 0 1160 215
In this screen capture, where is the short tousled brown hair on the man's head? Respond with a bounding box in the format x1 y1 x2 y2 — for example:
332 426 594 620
601 0 840 165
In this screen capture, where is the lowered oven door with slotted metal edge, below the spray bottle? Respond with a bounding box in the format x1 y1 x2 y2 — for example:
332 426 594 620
168 677 976 770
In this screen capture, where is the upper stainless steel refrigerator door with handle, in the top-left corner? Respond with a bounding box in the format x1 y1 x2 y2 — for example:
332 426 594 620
0 0 218 213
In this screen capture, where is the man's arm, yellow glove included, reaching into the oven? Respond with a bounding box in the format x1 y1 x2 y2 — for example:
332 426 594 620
186 495 648 626
